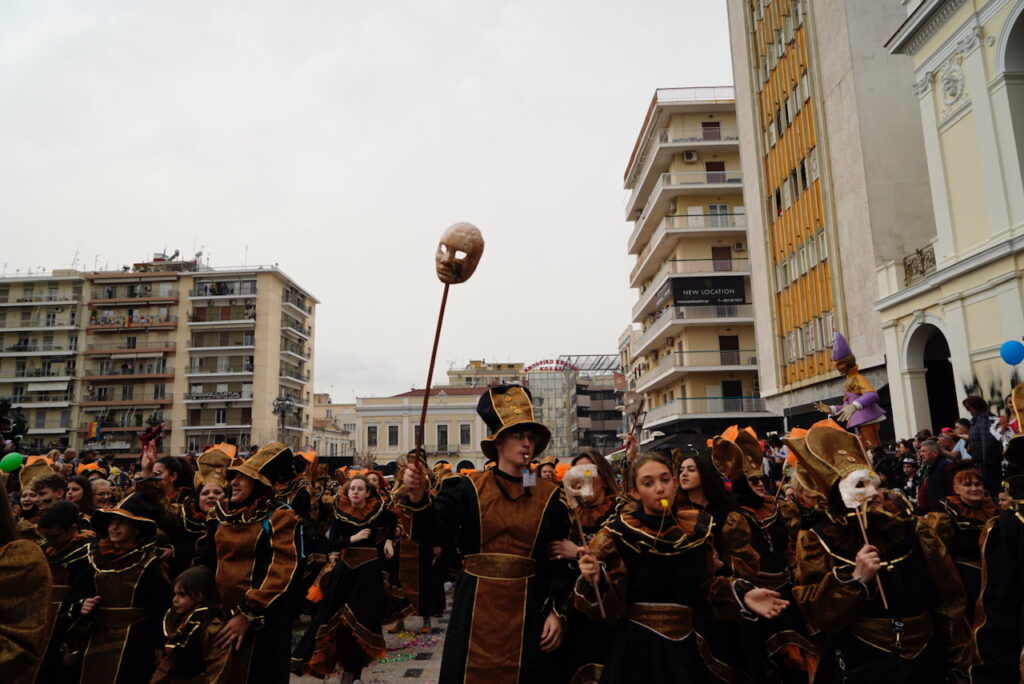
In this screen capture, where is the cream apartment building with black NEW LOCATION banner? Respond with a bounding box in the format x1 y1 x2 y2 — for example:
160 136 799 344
620 87 778 444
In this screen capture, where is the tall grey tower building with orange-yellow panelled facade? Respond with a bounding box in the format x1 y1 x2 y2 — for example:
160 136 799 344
728 0 934 437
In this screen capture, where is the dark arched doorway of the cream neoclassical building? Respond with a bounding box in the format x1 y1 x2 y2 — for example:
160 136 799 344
901 324 959 436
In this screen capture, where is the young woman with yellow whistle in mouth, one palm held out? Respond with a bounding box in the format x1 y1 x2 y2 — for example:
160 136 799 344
575 454 787 683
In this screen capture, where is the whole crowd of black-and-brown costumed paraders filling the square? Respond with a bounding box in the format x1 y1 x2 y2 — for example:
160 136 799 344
0 378 1024 684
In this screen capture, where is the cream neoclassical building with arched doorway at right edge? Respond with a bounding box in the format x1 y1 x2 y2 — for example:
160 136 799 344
876 0 1024 435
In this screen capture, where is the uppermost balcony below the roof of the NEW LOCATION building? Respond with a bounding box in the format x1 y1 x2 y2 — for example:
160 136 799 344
627 126 739 215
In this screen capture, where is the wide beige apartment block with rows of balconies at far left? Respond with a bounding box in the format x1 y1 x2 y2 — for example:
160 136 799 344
0 255 316 455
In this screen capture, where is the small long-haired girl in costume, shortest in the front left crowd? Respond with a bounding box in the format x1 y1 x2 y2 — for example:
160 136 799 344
150 565 231 684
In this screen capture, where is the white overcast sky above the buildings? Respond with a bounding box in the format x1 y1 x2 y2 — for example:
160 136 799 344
0 0 731 401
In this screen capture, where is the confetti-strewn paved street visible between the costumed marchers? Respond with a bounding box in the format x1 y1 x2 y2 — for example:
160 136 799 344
292 592 452 684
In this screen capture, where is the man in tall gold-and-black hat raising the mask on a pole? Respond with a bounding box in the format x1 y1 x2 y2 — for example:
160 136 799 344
398 385 574 684
